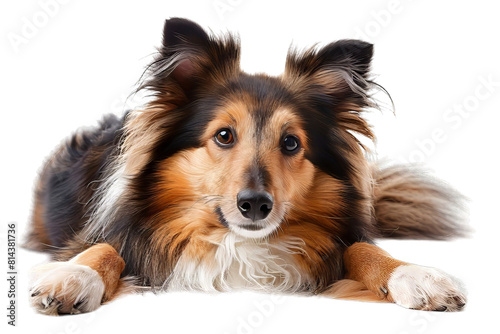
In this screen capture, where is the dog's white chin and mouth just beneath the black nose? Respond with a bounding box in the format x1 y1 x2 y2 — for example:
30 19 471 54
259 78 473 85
215 207 281 239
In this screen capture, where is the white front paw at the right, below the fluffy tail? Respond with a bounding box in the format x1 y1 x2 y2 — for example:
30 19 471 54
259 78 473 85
387 265 466 311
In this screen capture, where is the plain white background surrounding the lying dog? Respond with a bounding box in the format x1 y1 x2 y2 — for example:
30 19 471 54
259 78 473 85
0 0 500 334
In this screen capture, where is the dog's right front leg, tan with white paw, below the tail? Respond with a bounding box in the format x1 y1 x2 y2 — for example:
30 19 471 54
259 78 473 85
344 242 466 311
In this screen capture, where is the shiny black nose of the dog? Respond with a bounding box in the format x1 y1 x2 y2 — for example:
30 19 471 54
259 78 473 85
236 189 273 221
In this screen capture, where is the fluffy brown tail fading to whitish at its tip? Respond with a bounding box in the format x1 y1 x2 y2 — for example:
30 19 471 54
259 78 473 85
373 166 470 240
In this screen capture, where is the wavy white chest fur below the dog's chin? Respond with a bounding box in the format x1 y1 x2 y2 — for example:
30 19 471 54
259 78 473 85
165 232 309 292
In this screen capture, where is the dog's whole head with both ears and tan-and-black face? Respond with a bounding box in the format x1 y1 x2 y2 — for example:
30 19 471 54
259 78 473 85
125 19 372 238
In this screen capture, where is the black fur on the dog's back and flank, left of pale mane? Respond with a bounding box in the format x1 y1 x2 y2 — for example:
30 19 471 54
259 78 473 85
38 115 123 247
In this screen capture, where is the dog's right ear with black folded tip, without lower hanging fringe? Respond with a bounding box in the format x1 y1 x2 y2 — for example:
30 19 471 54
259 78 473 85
284 39 373 111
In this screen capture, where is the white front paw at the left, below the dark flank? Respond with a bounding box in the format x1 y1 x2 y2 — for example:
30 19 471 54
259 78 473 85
30 262 105 315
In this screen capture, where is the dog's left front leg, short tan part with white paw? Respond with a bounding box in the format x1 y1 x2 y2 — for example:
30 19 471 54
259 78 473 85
30 244 125 315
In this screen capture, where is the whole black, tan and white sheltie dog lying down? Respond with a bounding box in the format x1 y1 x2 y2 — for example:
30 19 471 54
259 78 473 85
26 18 466 314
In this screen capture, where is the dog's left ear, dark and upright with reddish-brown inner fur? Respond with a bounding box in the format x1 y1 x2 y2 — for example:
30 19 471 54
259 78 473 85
140 18 240 104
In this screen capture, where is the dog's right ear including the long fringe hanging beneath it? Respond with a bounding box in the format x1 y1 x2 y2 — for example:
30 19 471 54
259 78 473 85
283 39 378 142
